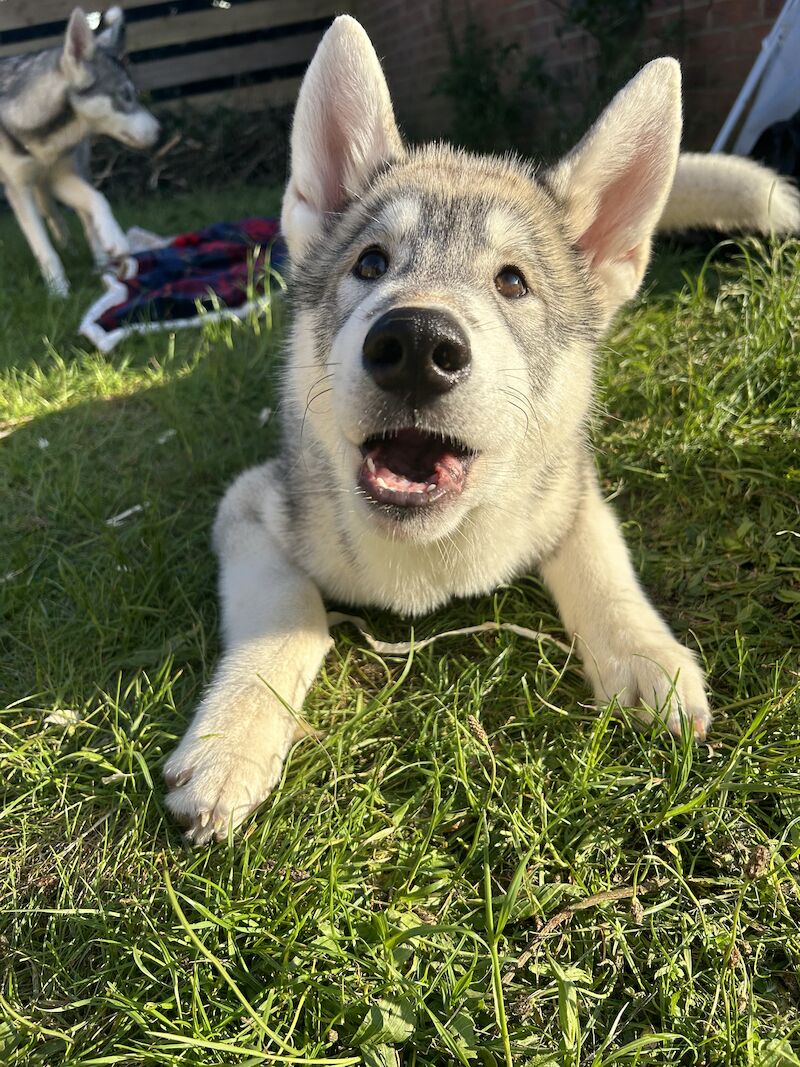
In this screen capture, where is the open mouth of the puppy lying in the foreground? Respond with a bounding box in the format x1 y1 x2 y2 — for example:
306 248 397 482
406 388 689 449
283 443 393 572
358 430 475 509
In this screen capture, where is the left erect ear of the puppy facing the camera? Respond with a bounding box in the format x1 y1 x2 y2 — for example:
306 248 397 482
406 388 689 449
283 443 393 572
281 15 403 258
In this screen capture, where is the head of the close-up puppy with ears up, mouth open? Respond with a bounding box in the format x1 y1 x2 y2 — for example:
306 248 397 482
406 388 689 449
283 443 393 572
282 16 681 541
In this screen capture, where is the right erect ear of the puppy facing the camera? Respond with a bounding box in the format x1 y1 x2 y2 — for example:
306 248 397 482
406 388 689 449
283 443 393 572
547 59 681 320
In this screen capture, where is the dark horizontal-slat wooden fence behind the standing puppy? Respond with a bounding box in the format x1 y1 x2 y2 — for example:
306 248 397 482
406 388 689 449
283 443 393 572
0 0 347 109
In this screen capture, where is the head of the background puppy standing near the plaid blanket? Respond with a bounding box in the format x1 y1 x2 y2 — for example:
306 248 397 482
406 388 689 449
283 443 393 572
61 7 159 148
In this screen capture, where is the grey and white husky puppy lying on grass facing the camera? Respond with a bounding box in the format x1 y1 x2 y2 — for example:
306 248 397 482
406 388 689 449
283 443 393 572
164 16 800 844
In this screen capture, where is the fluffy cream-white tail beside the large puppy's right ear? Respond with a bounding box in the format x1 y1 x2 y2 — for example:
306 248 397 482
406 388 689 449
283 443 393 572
658 153 800 235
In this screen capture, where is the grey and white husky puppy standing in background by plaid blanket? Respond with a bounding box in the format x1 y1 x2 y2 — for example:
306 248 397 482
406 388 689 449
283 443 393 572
0 7 159 296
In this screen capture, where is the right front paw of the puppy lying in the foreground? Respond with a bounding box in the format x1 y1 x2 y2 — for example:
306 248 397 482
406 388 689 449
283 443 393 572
593 640 711 740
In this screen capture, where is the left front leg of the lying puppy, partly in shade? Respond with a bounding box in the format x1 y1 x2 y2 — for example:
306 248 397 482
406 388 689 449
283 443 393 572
164 464 331 844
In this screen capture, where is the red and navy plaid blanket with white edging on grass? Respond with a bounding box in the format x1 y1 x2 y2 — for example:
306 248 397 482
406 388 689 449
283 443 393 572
80 218 286 352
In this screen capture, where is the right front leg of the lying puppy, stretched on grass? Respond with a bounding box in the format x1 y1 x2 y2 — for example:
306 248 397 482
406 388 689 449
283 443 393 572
541 476 711 737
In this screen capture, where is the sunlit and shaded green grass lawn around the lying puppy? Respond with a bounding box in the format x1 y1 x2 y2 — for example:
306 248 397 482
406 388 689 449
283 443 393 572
0 189 800 1067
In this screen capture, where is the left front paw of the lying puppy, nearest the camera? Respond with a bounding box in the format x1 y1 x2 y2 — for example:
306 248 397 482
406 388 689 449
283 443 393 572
163 687 298 845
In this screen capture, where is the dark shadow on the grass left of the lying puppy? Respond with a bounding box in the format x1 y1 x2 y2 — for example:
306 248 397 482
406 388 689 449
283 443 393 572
2 338 276 702
